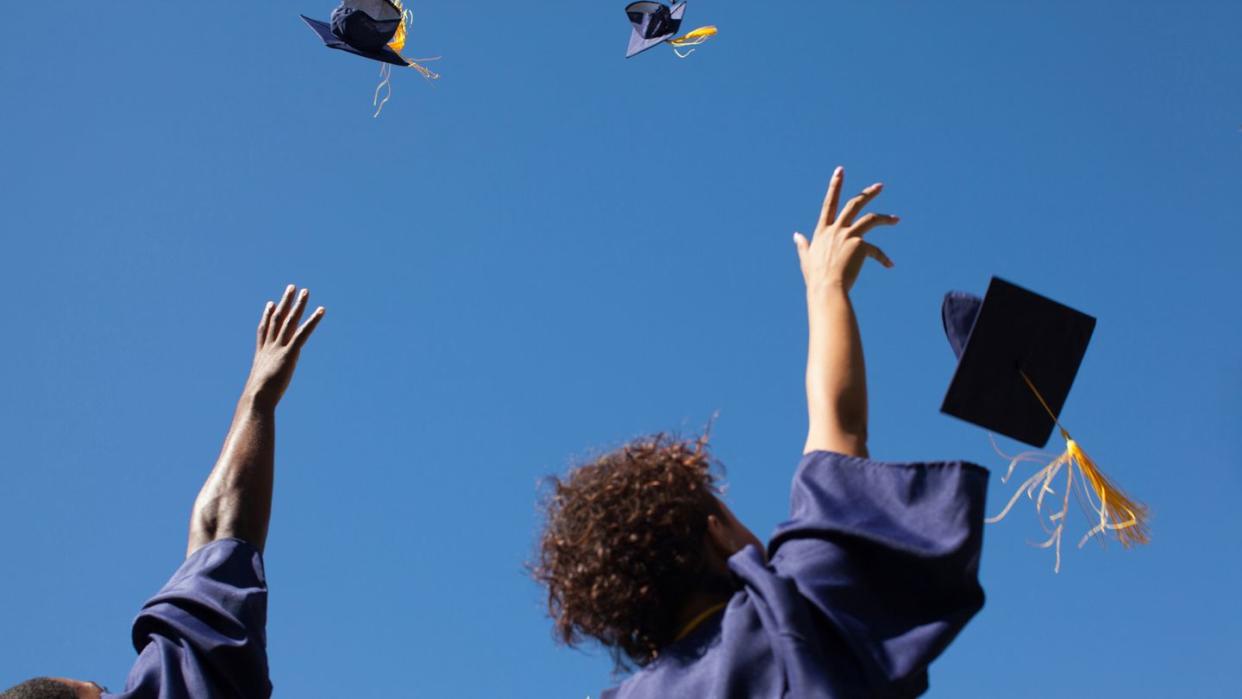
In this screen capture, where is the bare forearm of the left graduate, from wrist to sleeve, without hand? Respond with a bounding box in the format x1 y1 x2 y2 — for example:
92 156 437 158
186 391 276 555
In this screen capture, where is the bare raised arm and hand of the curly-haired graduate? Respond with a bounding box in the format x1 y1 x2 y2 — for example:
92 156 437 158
794 168 898 457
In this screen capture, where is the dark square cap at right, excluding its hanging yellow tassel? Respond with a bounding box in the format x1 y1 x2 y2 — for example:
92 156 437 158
940 277 1095 447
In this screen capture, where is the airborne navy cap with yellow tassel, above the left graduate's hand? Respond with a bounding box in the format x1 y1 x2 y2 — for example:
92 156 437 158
302 0 440 117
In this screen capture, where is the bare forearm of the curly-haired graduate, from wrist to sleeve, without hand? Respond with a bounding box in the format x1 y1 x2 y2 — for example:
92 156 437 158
804 286 867 457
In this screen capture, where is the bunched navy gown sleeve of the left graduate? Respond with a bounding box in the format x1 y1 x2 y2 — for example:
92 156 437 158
122 539 272 699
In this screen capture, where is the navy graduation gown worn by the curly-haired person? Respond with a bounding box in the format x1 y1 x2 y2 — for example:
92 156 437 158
604 452 987 699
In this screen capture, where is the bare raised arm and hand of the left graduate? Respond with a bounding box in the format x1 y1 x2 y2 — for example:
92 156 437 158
186 284 324 556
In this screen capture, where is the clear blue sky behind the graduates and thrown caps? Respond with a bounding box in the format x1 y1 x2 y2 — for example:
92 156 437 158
0 0 1242 699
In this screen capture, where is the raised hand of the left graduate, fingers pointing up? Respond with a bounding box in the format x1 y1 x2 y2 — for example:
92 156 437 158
246 284 324 410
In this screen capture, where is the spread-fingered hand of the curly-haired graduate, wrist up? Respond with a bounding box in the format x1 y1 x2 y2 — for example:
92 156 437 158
794 168 899 293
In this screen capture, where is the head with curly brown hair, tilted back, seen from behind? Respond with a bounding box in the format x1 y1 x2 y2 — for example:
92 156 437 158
533 435 763 668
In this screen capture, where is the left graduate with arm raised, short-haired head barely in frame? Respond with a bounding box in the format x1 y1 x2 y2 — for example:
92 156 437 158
0 286 324 699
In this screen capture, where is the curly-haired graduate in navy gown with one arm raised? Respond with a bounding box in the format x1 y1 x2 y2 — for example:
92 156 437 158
533 168 987 699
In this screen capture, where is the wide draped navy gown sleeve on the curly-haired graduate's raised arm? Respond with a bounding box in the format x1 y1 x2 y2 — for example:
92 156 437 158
769 452 987 697
